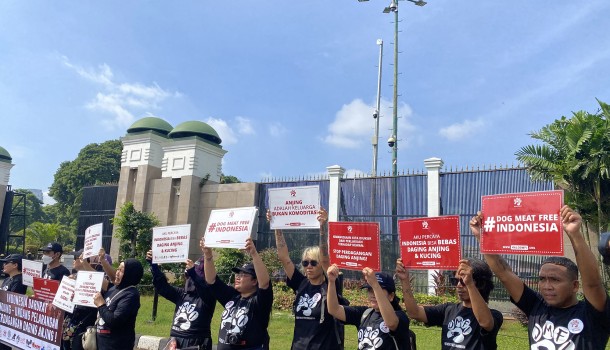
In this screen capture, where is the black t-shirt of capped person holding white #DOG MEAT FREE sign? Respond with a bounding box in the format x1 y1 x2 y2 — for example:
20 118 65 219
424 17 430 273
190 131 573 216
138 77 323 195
210 278 273 350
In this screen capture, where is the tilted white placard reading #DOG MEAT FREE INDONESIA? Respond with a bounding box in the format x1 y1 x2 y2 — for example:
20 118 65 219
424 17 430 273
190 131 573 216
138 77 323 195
205 207 258 249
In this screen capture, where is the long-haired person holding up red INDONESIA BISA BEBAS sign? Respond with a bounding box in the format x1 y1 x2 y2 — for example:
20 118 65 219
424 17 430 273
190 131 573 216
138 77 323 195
396 258 503 350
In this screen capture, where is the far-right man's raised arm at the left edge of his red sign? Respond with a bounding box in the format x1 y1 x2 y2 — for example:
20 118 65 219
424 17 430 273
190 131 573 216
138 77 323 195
470 212 525 302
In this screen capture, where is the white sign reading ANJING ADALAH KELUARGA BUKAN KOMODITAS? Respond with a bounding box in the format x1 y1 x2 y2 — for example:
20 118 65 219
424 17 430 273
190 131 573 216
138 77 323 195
268 186 320 230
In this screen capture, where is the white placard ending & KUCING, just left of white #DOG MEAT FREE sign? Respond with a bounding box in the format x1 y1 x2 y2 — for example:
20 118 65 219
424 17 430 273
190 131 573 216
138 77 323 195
152 224 191 264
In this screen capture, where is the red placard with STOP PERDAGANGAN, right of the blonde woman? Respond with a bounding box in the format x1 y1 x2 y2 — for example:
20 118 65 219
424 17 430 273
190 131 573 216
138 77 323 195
328 222 381 271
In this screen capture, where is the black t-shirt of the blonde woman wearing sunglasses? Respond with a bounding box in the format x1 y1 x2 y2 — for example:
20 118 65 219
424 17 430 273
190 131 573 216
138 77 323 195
286 269 341 350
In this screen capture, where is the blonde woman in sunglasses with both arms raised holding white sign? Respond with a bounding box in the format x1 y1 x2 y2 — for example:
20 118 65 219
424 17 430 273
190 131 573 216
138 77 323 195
267 208 343 350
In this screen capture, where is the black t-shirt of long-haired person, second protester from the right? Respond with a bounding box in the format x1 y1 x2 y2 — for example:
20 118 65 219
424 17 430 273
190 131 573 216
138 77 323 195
424 303 504 350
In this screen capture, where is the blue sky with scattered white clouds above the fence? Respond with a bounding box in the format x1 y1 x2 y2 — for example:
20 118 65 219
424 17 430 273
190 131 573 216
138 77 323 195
0 0 610 202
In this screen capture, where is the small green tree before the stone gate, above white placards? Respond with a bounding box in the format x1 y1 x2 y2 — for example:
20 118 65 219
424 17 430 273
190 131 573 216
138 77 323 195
112 202 159 260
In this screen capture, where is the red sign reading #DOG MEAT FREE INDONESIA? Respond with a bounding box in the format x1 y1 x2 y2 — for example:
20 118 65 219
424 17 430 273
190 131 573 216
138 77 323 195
481 191 563 256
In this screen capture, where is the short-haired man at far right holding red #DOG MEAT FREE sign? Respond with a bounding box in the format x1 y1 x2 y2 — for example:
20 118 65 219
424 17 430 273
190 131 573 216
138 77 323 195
470 205 610 350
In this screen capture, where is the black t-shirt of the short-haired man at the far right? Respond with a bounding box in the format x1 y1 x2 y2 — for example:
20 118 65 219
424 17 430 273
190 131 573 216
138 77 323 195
511 286 610 350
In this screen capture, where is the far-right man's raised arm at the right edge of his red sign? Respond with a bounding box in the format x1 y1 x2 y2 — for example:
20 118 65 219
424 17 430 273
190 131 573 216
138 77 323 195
561 205 608 311
